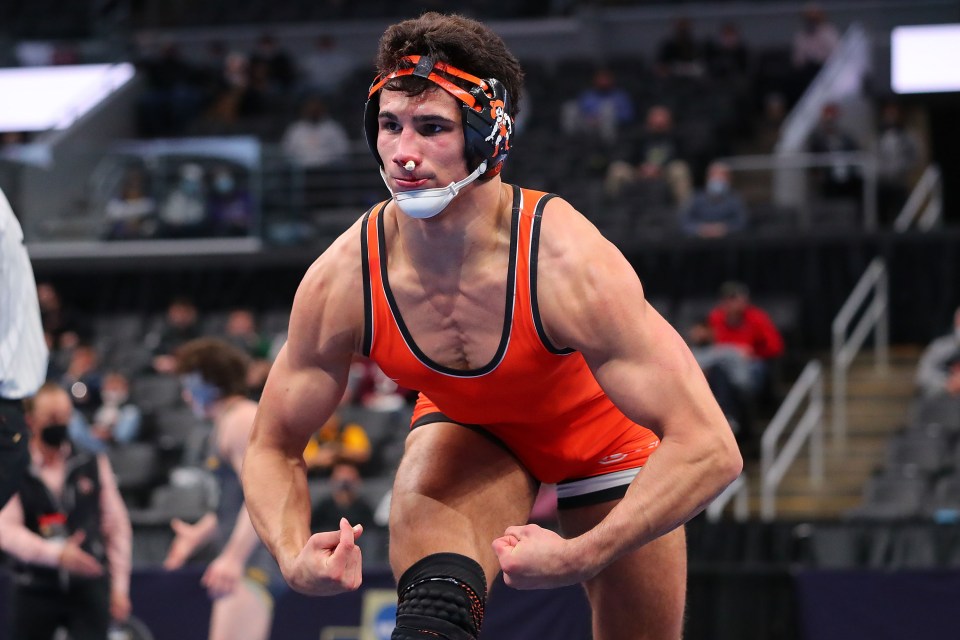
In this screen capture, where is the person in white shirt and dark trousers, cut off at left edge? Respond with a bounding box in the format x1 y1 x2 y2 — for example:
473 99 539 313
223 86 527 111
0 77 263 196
0 185 49 508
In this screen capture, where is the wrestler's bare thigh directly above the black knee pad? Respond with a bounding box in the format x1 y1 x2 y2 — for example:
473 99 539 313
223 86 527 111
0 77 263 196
390 422 537 583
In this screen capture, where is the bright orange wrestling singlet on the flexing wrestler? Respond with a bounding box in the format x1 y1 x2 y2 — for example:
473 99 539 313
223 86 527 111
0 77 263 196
361 187 659 483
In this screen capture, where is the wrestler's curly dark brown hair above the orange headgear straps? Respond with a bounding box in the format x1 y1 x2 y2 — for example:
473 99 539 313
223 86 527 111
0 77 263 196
377 11 523 118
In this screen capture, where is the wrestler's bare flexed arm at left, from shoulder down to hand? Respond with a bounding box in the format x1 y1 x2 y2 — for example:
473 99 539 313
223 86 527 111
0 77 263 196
242 225 363 594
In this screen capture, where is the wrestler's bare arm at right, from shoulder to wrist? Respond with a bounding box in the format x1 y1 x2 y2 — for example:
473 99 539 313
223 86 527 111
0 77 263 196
538 201 742 572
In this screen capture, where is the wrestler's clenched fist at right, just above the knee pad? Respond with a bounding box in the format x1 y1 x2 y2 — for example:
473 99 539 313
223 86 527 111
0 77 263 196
493 524 592 589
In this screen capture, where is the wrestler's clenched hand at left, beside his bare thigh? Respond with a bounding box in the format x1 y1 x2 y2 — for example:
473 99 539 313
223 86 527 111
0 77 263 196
280 518 363 596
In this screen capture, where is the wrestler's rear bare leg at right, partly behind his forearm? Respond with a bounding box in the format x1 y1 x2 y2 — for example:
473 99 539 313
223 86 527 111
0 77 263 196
558 501 687 640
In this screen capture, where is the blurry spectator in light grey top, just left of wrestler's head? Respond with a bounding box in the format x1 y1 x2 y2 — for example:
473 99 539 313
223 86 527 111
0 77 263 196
280 96 350 169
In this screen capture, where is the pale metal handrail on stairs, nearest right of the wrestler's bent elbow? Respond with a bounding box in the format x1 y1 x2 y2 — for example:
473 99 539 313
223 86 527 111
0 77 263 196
760 360 824 521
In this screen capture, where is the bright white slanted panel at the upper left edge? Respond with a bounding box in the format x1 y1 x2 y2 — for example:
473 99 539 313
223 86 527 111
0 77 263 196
0 62 135 133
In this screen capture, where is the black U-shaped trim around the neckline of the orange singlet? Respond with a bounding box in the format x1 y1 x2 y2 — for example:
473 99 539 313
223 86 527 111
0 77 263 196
377 186 521 378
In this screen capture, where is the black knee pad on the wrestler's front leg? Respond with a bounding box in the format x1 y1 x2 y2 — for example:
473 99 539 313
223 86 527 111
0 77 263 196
390 553 487 640
